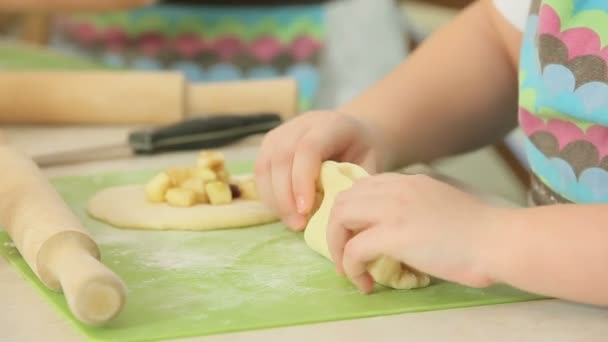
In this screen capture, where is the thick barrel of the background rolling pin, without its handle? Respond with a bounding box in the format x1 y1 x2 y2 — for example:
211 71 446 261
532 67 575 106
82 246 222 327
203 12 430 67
0 71 186 125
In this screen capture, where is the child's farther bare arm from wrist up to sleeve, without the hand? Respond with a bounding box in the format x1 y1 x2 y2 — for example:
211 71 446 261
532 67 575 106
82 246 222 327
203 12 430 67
339 0 521 167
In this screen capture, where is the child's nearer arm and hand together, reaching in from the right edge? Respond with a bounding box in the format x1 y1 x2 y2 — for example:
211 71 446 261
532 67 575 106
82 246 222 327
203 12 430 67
327 174 608 306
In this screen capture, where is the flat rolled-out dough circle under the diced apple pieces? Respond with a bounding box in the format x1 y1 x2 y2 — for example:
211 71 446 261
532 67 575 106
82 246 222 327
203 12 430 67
88 185 278 230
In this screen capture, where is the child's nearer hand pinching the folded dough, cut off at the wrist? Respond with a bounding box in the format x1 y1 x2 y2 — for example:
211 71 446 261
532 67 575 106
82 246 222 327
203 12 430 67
327 174 496 293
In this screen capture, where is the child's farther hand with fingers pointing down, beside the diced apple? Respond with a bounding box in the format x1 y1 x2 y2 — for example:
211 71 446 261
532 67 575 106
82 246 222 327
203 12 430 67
255 111 381 230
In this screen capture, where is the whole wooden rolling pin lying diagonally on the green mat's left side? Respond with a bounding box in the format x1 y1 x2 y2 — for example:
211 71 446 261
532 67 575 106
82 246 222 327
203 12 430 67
0 143 126 325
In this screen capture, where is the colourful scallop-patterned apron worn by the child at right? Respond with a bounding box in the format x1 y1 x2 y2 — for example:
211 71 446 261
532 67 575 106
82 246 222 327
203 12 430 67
519 0 608 203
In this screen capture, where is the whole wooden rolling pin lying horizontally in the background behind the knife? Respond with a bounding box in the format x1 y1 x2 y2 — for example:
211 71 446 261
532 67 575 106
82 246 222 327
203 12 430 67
0 71 298 124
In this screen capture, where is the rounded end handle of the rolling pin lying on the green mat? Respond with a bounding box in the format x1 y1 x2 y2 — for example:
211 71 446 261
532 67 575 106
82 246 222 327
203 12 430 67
37 231 126 325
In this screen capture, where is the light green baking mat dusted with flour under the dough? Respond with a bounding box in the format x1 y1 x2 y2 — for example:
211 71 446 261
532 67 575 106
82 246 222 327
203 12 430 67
0 162 540 341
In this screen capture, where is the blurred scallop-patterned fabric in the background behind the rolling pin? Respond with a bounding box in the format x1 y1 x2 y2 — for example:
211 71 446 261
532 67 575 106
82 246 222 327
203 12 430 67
53 5 324 110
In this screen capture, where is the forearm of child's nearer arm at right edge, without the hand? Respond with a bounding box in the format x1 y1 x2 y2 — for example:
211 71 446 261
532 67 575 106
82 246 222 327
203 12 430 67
482 205 608 306
